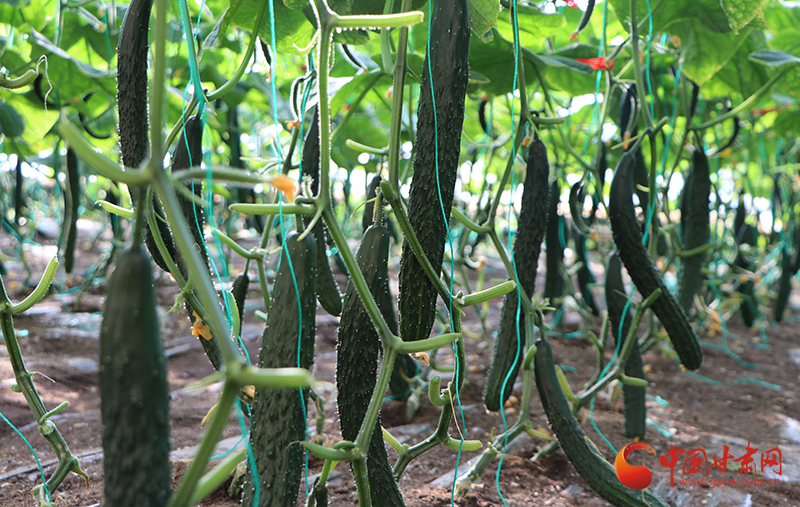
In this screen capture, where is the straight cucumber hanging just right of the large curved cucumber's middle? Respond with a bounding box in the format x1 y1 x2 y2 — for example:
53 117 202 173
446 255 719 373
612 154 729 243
678 148 711 314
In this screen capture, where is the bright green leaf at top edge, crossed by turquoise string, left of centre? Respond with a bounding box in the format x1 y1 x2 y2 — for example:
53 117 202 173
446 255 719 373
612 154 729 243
219 0 314 56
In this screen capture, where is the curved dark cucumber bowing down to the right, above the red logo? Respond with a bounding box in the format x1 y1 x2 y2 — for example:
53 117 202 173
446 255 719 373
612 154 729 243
608 153 703 370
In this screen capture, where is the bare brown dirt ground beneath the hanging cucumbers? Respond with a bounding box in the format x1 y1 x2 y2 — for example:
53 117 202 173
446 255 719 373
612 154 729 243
0 223 800 507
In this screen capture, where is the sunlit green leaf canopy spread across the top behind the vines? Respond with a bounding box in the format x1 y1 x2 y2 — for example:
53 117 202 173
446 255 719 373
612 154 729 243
0 0 800 204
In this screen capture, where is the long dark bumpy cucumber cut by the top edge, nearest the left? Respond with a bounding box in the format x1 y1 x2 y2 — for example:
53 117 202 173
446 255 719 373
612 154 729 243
117 0 153 169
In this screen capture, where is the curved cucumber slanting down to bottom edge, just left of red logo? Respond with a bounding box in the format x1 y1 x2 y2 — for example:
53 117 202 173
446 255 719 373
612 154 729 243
534 338 668 507
